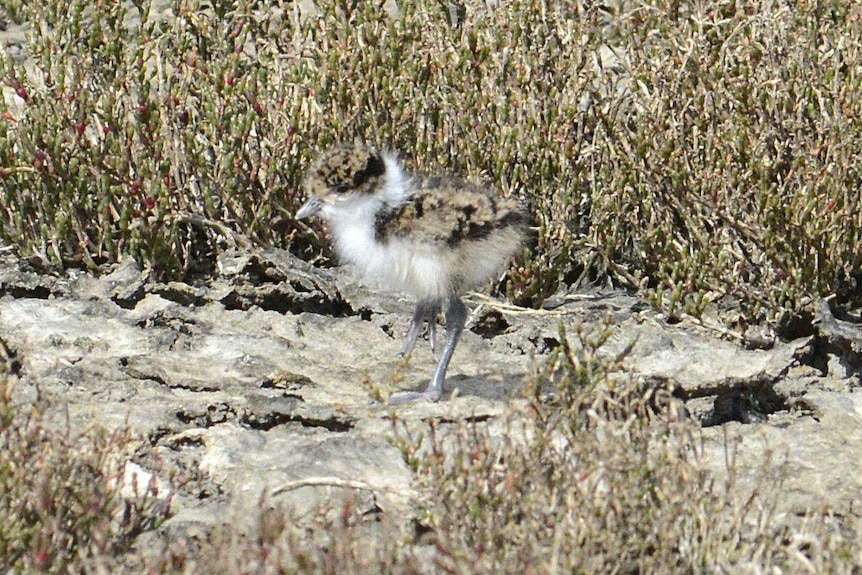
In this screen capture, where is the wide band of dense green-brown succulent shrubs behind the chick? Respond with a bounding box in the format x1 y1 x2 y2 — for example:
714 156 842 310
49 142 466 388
0 0 862 329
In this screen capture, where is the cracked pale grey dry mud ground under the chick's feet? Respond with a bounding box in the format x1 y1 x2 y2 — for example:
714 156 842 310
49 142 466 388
0 250 862 560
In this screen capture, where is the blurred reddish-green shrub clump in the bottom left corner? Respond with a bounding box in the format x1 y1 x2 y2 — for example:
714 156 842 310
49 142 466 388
0 376 169 573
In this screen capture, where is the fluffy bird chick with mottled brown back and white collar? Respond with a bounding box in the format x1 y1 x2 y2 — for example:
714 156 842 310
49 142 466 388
296 144 526 404
